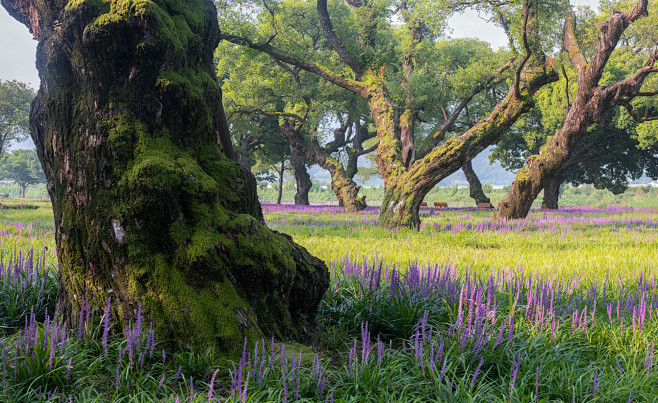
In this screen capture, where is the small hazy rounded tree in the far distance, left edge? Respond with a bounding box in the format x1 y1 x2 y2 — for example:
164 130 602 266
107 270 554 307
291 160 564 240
0 150 46 199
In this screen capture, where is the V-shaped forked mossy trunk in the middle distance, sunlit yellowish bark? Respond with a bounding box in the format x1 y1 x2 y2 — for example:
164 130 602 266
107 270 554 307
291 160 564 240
370 57 557 228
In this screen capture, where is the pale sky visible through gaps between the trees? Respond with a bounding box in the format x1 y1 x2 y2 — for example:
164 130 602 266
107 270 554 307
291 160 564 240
0 0 599 148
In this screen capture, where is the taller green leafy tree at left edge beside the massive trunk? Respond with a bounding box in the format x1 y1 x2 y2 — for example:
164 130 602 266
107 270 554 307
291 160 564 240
0 80 35 156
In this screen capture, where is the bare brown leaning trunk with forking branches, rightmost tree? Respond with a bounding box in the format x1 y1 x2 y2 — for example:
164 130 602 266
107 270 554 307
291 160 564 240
499 0 658 219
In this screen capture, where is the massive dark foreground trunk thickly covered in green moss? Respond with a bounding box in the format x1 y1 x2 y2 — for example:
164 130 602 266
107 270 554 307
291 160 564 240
2 0 329 355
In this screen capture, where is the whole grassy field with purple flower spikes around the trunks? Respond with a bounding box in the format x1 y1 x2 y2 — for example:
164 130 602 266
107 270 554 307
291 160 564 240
0 205 658 402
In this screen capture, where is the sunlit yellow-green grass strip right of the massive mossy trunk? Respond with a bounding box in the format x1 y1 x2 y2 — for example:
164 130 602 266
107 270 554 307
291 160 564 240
266 211 658 279
